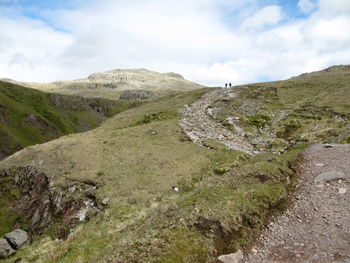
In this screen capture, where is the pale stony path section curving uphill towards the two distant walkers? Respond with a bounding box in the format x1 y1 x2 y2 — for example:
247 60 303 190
179 89 254 154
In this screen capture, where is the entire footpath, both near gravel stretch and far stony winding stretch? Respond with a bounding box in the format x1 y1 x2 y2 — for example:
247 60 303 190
179 89 350 263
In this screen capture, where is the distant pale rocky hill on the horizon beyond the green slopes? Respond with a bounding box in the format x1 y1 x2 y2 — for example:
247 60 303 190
1 69 203 99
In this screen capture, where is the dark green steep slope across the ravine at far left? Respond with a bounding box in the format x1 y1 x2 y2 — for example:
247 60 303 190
0 81 132 159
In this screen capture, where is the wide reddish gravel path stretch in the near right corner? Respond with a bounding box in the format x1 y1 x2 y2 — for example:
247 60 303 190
244 145 350 263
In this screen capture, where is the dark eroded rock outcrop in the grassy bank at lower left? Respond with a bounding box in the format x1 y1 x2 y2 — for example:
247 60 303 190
0 166 99 239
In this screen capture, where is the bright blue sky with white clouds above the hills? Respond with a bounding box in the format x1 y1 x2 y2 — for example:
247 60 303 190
0 0 350 86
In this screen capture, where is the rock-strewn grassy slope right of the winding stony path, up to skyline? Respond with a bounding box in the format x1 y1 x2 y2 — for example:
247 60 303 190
213 66 350 151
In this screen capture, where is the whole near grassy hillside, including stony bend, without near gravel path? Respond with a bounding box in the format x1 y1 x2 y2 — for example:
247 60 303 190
0 66 350 263
